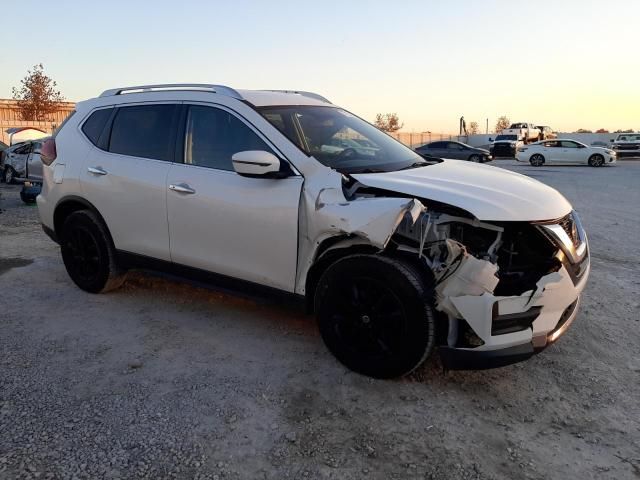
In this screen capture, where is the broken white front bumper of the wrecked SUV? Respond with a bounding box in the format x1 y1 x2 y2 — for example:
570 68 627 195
439 253 590 370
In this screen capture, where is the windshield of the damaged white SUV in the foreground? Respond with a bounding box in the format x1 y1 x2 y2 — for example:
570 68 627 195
258 105 429 173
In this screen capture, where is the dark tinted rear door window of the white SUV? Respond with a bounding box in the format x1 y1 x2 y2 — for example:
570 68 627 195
109 105 176 161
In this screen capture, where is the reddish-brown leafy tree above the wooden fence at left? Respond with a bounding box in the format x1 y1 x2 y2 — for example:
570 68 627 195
12 63 64 121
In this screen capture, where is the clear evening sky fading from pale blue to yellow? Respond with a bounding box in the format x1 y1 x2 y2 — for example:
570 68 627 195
0 0 640 133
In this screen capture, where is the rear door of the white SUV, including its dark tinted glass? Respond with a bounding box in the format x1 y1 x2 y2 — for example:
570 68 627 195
81 102 181 261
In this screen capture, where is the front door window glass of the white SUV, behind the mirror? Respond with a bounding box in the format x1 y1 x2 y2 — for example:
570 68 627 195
184 105 273 171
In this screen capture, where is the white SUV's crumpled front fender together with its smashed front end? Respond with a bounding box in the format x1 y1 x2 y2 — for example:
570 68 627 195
298 172 589 369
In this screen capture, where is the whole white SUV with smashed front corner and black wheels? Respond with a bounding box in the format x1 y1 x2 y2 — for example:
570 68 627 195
37 84 589 378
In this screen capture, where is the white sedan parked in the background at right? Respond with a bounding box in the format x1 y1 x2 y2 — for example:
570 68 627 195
516 139 616 167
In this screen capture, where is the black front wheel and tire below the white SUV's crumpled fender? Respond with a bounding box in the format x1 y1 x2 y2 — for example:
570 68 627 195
314 255 435 378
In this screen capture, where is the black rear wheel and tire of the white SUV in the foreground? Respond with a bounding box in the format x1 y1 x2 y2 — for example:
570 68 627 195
60 210 126 293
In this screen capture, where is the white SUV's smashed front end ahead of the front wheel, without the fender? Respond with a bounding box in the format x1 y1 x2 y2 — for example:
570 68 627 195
394 211 589 369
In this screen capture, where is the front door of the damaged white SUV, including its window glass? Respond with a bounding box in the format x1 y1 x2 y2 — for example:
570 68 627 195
167 104 303 291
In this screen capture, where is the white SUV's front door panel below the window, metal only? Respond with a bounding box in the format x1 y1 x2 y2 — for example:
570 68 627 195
167 163 303 291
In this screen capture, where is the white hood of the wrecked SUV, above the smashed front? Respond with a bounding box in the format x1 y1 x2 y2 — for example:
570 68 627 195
351 160 571 222
